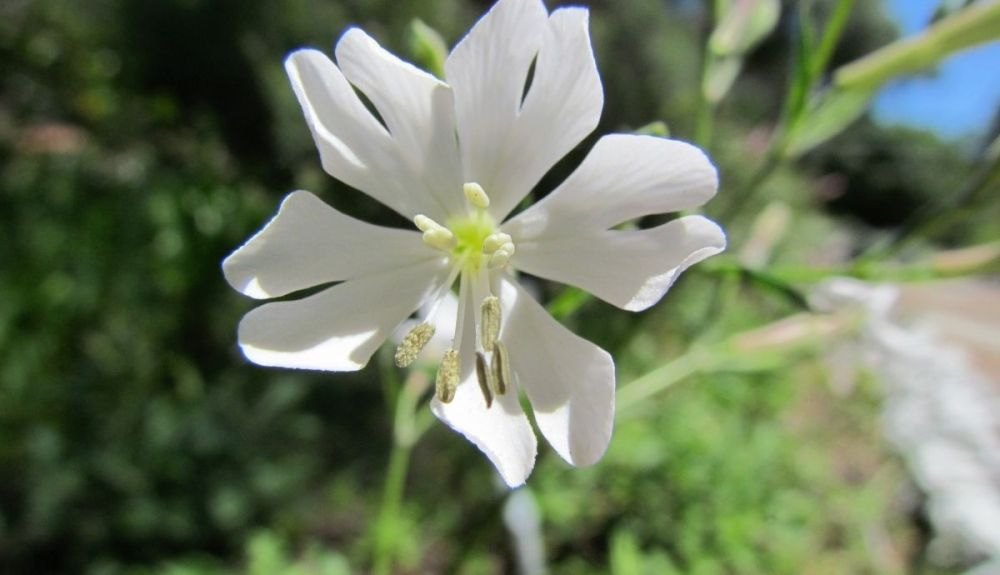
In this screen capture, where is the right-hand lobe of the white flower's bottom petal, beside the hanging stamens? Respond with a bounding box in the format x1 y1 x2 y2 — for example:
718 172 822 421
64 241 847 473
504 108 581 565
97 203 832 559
500 278 615 466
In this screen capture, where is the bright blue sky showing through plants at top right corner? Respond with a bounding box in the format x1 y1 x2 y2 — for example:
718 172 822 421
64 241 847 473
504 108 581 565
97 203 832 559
874 0 1000 138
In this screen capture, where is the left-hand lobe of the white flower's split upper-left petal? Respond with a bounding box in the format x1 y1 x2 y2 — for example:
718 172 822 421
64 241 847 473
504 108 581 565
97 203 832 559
285 50 447 219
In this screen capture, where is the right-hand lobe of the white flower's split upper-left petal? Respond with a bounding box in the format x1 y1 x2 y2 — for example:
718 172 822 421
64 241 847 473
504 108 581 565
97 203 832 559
336 28 465 217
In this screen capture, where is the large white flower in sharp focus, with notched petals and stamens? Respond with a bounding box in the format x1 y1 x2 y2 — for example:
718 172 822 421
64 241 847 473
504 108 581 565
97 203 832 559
223 0 725 486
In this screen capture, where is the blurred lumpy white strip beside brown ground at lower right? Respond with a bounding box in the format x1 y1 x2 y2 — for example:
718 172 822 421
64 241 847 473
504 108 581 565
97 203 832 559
813 278 1000 573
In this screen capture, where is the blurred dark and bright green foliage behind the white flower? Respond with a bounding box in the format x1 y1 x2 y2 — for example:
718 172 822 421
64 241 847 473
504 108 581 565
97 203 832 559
0 0 1000 575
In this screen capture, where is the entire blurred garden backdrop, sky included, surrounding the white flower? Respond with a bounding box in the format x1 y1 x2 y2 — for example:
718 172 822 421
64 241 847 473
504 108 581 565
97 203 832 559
0 0 1000 575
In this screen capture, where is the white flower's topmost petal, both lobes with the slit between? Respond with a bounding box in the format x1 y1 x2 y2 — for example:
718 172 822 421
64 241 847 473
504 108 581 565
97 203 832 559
445 0 604 220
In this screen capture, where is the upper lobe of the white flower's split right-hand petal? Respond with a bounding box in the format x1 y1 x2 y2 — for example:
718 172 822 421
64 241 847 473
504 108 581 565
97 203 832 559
505 134 718 239
